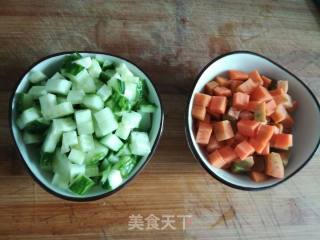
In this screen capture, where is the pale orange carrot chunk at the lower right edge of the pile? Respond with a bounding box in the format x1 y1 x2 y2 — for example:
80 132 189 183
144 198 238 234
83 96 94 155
265 152 284 178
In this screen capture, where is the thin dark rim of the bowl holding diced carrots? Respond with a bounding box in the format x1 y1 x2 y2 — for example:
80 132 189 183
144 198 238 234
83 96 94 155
184 50 320 191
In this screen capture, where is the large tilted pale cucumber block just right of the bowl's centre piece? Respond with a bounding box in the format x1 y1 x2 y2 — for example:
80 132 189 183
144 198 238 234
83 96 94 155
94 107 118 136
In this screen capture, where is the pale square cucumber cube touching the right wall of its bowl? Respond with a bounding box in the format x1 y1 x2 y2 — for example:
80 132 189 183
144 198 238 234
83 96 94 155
130 131 151 156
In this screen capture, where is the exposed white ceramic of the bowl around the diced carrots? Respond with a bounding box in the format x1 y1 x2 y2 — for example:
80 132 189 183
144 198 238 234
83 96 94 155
185 51 320 190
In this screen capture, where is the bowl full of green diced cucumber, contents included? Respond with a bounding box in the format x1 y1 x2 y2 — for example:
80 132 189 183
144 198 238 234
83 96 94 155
10 52 164 201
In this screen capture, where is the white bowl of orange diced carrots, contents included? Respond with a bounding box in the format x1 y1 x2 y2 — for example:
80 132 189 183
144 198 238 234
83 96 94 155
186 51 320 190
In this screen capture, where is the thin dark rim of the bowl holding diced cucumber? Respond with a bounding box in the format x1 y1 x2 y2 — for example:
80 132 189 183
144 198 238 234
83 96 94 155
9 51 164 202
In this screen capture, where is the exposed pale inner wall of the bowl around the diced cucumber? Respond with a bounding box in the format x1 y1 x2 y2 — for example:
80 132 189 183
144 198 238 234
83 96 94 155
11 53 163 199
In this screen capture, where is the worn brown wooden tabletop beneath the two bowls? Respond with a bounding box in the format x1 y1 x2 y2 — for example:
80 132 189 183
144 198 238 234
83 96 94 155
0 0 320 239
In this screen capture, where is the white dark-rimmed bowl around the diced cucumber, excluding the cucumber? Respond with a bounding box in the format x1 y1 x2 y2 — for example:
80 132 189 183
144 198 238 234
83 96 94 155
9 52 164 201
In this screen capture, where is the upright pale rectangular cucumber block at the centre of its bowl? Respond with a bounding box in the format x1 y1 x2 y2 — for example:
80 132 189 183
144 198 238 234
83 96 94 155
74 109 94 134
